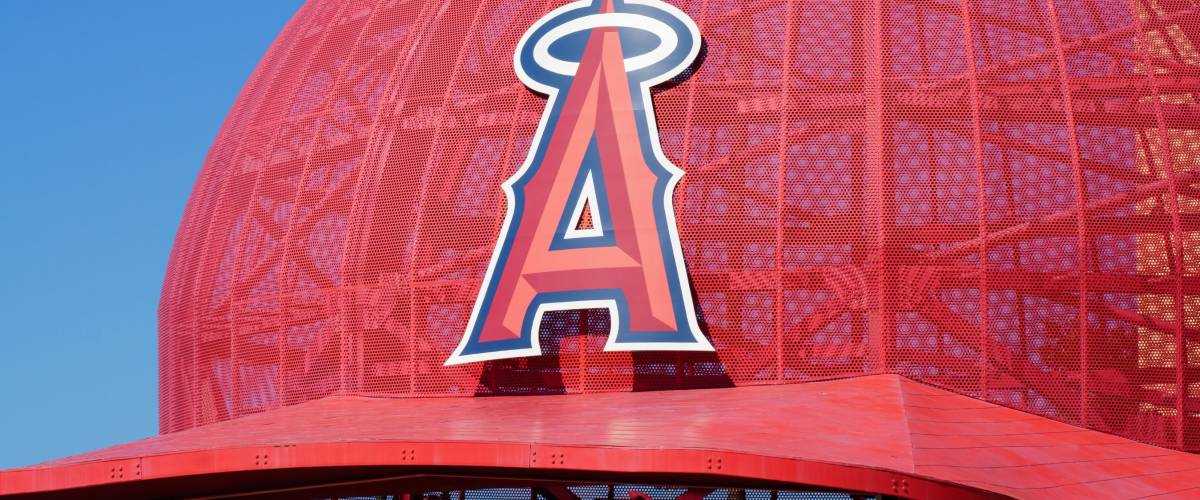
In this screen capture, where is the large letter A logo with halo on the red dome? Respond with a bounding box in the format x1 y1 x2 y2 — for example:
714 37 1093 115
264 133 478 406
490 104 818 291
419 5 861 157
446 0 713 365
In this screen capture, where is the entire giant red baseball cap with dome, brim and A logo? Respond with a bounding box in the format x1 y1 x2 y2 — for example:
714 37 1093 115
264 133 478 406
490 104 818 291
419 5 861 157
0 0 1200 500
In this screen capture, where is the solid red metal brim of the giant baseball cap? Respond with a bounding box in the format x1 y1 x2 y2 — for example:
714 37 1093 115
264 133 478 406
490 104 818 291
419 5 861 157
7 375 1200 498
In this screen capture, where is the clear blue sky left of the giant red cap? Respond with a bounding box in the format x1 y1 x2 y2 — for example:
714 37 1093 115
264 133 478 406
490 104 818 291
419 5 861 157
0 0 301 469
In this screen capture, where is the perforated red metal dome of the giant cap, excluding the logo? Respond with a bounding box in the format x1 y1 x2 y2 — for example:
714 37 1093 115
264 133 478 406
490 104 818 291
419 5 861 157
160 0 1200 451
